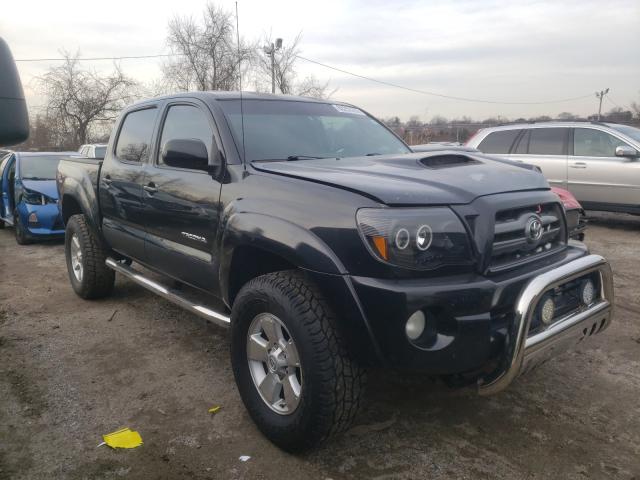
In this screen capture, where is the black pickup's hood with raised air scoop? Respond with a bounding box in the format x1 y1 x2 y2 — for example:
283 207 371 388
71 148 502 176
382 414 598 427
252 150 549 205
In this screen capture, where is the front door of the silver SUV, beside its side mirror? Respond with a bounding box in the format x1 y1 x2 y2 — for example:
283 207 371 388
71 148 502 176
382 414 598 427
569 126 640 209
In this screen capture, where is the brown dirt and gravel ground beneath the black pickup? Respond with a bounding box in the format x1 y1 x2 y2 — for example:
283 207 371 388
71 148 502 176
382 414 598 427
0 214 640 480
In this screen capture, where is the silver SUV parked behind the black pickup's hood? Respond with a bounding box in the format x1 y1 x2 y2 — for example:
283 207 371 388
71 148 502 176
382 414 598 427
466 122 640 214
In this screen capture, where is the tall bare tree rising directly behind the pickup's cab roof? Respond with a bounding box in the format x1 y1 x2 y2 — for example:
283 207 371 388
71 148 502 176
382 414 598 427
163 3 255 91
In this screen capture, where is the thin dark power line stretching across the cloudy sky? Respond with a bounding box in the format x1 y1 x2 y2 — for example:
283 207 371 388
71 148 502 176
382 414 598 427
16 53 591 105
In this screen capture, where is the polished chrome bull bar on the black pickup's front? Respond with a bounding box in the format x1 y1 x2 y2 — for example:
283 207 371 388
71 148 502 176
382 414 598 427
478 255 614 395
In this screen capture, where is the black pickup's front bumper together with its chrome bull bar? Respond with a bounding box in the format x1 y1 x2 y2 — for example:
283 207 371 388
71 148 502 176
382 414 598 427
344 243 613 392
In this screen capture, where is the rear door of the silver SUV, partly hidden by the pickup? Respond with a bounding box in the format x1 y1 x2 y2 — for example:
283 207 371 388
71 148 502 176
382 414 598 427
509 127 569 188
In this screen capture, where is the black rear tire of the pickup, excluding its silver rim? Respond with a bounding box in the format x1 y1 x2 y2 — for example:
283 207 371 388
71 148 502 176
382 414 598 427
64 214 115 299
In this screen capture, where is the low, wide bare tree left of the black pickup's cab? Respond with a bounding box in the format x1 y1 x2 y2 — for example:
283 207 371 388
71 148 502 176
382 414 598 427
38 52 137 145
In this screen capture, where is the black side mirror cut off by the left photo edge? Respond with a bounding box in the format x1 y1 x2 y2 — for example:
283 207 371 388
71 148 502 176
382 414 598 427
0 38 29 146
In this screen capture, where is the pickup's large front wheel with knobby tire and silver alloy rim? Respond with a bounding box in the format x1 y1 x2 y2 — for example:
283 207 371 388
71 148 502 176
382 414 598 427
231 271 365 453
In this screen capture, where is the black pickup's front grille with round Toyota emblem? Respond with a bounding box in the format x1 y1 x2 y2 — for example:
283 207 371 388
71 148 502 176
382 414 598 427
489 203 566 271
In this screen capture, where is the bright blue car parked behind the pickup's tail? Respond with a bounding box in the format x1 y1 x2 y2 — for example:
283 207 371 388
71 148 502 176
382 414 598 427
0 152 77 245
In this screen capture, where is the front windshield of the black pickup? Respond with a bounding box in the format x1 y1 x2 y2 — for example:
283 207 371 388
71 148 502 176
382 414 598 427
219 100 411 161
